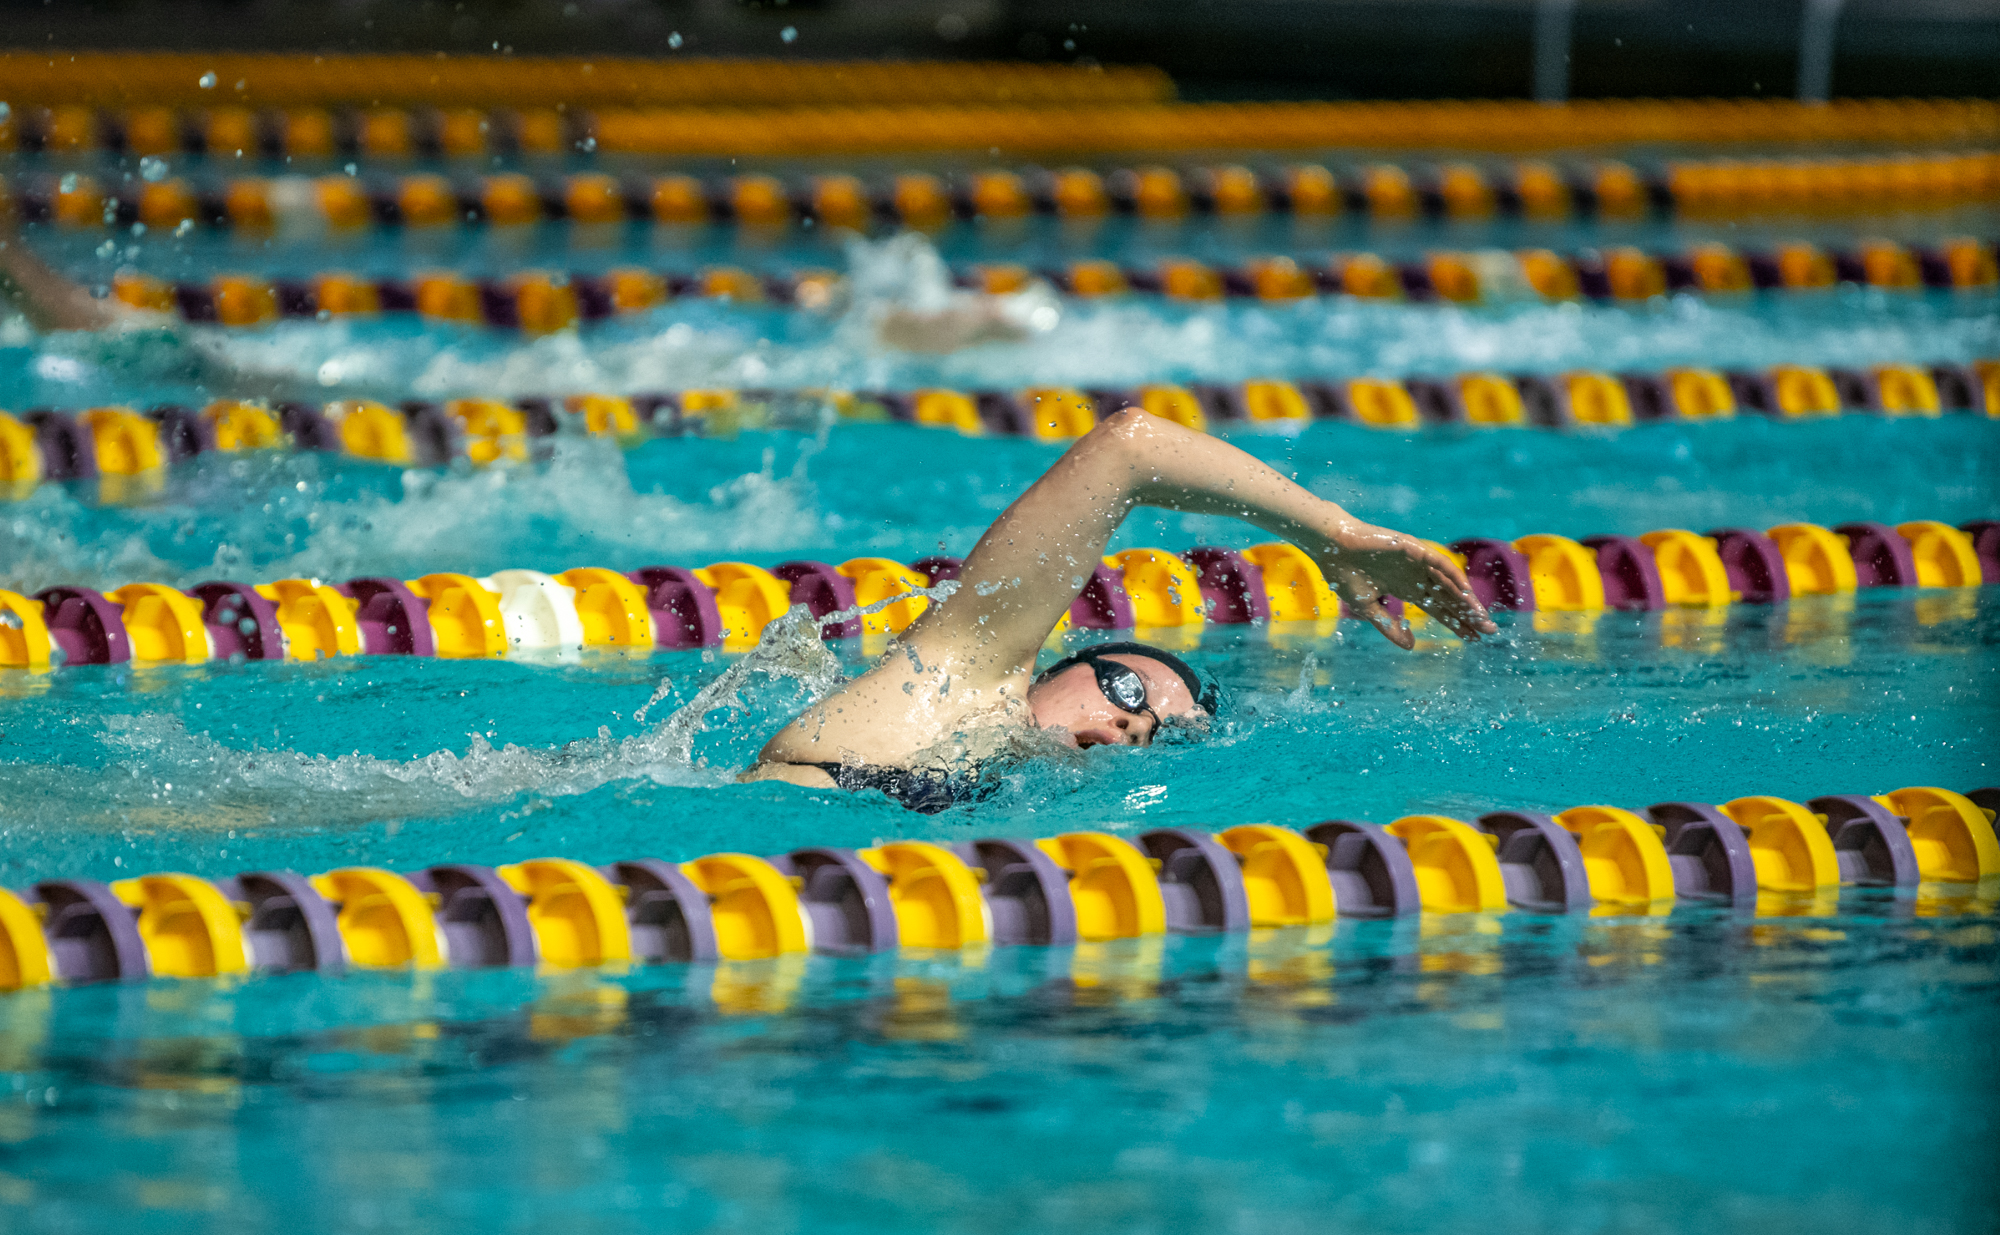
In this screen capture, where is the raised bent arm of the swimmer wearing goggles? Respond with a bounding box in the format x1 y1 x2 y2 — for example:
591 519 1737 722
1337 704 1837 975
904 408 1496 677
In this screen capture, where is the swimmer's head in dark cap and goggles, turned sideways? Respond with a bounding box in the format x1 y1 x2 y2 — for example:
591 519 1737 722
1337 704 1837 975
1028 643 1222 747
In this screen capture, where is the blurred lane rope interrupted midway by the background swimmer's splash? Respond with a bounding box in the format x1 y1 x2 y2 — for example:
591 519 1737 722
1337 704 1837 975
66 238 2000 334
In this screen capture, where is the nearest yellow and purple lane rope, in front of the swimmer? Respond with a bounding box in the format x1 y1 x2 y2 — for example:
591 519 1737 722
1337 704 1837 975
0 785 2000 991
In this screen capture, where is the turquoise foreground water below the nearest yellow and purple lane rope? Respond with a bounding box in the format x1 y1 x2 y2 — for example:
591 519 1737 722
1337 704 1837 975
0 903 1996 1233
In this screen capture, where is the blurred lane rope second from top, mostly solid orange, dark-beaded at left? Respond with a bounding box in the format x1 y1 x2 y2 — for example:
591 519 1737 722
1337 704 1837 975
0 93 2000 158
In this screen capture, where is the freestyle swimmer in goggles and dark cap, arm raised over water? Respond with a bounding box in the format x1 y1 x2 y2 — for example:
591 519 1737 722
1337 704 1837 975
742 408 1496 811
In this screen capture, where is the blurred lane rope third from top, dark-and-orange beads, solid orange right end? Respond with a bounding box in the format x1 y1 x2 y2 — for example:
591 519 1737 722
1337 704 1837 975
10 149 2000 232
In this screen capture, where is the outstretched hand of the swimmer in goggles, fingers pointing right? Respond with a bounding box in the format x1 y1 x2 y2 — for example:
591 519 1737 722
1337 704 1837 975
1302 516 1500 649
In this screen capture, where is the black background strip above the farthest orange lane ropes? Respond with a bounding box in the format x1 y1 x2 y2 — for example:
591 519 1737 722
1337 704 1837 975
0 0 2000 98
